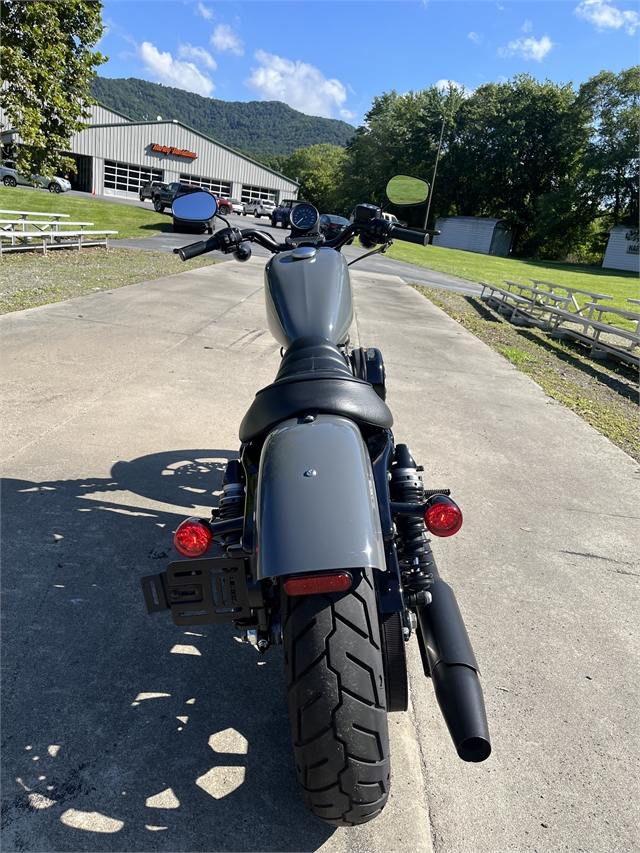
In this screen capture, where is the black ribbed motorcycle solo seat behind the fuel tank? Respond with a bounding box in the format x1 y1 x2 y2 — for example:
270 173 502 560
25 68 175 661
240 335 393 441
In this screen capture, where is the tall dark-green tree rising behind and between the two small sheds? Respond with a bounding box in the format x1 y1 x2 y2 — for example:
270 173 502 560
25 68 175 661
440 74 589 257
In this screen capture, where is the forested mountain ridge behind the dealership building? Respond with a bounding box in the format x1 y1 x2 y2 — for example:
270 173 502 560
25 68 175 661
91 77 355 157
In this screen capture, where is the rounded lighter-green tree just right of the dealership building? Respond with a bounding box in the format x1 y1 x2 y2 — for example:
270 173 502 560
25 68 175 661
281 142 347 213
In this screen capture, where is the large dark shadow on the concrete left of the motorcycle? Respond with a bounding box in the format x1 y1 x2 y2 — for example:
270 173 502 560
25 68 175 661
2 450 333 851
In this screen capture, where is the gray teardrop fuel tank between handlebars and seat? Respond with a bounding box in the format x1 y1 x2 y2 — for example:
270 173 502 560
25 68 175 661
264 247 353 347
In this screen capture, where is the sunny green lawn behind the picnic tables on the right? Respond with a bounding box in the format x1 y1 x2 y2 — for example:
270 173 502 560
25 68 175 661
387 241 640 320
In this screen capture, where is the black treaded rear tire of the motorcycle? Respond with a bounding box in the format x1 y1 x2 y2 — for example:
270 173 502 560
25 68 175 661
282 569 390 826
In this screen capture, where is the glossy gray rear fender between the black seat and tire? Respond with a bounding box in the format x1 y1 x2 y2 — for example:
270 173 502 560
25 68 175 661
256 415 386 579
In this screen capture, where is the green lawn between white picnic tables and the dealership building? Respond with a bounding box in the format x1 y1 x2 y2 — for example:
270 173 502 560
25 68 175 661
0 186 172 239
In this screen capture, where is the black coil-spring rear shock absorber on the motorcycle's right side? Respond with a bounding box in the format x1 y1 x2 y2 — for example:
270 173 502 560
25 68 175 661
389 444 437 604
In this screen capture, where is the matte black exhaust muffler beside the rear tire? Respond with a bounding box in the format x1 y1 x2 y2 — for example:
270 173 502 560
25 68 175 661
416 571 491 761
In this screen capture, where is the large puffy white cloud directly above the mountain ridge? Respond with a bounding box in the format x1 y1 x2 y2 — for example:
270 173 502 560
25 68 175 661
245 50 347 118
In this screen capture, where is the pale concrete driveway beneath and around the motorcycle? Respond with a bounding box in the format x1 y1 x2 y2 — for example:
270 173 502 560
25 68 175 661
0 257 640 853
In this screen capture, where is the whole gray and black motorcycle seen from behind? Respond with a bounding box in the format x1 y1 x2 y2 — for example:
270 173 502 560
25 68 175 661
142 175 491 826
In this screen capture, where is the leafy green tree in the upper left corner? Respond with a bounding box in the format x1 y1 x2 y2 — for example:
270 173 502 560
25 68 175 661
0 0 107 174
